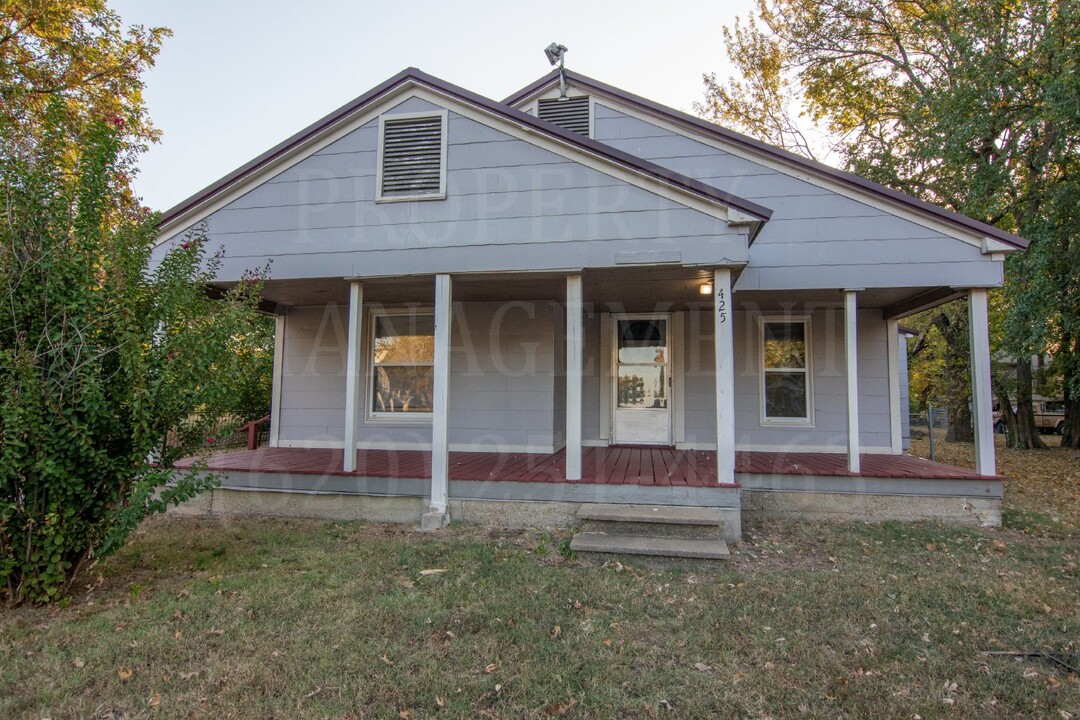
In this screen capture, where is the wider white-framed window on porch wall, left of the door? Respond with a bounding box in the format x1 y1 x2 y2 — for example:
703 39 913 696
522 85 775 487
367 310 435 420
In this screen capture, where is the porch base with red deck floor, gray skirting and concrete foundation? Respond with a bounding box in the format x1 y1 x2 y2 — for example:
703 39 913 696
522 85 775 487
174 446 1003 542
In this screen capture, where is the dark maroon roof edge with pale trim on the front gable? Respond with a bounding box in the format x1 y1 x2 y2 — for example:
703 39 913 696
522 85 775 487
159 68 772 228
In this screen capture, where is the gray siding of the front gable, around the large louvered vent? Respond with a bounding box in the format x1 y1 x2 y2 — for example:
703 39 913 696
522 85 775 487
159 98 746 280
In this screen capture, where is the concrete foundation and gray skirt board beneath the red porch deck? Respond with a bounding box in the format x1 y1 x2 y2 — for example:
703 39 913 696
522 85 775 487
170 476 1001 543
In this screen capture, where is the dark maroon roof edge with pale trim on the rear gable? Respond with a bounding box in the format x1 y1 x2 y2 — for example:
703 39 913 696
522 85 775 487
503 70 1028 249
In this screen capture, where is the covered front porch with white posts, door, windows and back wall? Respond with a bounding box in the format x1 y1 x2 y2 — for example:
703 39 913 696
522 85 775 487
236 264 1000 535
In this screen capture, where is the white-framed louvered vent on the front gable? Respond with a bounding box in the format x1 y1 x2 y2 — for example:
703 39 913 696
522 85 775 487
375 110 447 202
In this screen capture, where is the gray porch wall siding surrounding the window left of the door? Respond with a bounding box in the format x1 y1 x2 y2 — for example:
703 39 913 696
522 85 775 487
279 302 565 452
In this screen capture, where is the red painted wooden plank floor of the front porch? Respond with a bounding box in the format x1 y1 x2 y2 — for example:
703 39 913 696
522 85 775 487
177 446 1001 487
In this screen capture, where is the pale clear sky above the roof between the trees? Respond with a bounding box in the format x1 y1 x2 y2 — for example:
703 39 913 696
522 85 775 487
110 0 753 210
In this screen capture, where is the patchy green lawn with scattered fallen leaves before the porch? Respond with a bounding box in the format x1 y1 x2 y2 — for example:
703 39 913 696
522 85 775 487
0 517 1080 720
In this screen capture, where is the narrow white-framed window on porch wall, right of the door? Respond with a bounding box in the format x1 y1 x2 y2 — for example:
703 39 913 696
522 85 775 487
758 315 813 425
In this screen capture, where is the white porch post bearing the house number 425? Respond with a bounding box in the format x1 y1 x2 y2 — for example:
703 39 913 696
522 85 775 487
713 268 735 483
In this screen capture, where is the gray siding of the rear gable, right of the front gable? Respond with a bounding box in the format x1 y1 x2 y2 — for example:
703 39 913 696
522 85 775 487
594 103 1002 290
